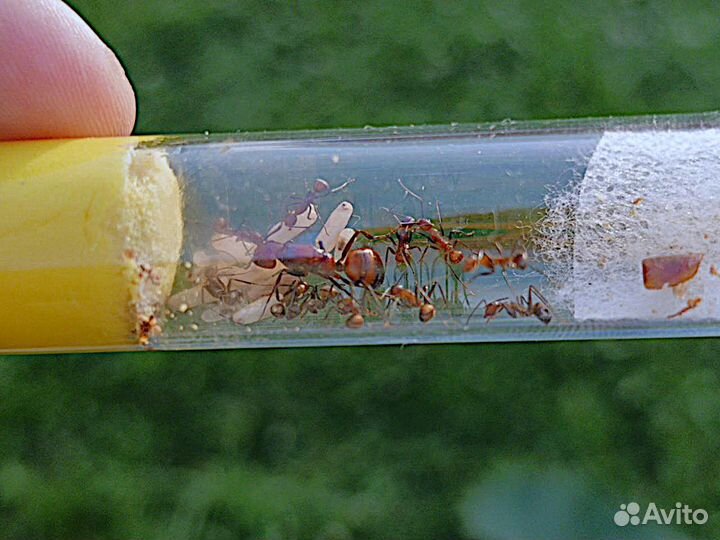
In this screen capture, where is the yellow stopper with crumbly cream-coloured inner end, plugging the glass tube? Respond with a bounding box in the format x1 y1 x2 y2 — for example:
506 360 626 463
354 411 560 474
0 137 183 351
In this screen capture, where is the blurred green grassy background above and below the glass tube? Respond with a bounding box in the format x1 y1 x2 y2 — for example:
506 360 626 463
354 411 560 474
0 0 720 540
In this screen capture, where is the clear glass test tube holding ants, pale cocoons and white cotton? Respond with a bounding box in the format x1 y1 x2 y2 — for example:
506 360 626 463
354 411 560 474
0 114 720 351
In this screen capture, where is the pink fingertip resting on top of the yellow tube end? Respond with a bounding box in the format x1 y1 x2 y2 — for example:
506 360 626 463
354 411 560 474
0 0 135 140
